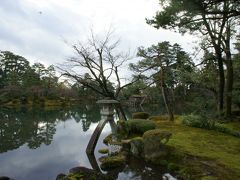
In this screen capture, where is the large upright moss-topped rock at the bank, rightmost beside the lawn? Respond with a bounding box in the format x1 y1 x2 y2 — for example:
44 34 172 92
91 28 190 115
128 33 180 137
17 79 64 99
143 129 172 163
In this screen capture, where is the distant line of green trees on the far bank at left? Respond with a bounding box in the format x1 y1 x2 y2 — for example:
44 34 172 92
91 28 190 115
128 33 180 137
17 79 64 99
0 51 102 105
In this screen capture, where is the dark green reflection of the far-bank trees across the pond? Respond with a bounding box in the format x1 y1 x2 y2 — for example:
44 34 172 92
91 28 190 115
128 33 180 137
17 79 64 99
0 107 100 153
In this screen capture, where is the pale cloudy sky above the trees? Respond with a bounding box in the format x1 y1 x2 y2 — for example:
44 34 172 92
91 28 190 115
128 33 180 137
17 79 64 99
0 0 198 68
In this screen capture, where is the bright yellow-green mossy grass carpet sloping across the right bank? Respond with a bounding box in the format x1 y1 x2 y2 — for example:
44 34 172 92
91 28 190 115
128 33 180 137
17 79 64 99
152 118 240 179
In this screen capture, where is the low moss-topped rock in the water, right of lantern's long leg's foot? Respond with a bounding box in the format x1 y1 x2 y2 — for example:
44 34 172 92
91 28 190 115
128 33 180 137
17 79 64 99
99 154 126 171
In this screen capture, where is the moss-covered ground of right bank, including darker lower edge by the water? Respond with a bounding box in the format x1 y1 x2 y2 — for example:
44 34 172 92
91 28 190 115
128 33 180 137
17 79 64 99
151 116 240 179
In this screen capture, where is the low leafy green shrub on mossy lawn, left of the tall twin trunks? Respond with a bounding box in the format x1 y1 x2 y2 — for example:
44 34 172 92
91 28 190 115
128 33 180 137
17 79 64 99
180 114 215 129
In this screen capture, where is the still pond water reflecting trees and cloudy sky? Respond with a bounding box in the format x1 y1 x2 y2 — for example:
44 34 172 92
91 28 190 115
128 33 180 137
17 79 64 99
0 106 176 180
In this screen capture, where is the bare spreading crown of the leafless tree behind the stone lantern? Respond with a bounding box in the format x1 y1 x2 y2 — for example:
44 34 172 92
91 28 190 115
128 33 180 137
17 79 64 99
59 30 137 119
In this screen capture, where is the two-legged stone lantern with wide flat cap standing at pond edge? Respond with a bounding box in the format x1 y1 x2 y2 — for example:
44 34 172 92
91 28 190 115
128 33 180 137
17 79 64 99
86 99 119 154
